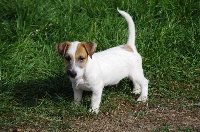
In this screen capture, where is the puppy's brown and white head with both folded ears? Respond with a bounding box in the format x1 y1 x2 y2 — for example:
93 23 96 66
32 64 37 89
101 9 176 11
56 42 96 79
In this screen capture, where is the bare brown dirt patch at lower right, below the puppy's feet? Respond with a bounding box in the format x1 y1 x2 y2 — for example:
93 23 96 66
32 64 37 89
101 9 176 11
72 103 200 132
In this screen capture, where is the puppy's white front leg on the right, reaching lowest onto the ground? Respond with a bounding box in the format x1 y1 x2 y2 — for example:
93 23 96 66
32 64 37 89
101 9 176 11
89 86 103 114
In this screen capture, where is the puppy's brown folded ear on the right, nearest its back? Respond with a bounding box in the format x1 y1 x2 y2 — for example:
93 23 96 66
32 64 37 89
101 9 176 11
82 42 97 59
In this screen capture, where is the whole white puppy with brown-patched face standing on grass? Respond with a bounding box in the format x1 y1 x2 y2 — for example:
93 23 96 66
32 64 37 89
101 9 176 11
56 9 148 113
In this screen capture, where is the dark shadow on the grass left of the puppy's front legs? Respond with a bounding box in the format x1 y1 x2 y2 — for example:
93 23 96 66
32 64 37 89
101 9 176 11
4 74 73 107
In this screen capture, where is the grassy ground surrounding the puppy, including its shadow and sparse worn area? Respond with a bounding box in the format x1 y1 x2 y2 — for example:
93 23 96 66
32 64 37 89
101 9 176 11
0 0 200 131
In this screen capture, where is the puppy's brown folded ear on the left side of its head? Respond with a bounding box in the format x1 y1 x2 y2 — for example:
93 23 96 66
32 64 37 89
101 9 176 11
56 42 71 56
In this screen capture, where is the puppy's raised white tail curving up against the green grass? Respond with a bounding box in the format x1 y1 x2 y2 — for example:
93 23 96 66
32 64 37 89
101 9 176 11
117 8 137 52
